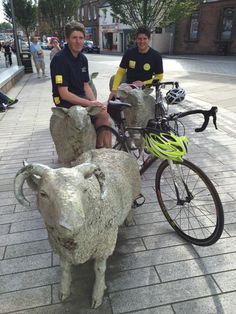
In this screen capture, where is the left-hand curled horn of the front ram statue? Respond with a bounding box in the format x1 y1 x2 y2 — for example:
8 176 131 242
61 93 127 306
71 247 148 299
14 164 50 207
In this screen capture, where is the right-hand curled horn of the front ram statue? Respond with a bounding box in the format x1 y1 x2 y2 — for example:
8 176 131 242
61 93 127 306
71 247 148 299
76 162 107 199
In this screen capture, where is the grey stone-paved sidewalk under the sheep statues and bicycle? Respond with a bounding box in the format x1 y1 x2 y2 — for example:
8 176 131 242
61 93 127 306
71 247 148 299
0 58 236 314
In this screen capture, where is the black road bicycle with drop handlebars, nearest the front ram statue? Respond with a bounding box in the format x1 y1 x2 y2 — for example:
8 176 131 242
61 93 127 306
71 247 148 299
97 85 224 246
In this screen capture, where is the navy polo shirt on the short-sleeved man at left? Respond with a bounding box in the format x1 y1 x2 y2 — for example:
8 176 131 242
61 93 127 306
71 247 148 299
50 45 89 108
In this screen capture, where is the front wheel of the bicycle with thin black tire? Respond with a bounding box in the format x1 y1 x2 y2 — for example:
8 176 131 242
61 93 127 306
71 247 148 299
155 160 224 246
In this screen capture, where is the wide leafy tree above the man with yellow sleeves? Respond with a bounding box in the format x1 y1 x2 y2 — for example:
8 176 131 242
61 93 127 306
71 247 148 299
108 0 196 30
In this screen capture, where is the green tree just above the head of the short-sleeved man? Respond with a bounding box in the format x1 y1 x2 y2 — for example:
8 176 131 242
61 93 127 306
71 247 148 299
38 0 80 38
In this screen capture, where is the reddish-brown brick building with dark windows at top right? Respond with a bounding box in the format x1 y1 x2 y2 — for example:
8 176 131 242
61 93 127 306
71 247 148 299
174 0 236 55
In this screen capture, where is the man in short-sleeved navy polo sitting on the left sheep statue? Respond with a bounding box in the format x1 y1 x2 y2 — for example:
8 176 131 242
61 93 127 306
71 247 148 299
50 21 111 148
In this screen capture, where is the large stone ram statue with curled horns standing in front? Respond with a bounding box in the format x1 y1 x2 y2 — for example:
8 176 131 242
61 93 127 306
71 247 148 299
14 149 140 308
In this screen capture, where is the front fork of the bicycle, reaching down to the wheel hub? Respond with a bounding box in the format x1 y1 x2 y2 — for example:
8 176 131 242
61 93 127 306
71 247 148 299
168 160 194 205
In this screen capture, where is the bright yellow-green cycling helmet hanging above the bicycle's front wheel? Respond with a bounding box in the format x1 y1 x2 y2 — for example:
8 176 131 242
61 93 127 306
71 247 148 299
145 131 188 161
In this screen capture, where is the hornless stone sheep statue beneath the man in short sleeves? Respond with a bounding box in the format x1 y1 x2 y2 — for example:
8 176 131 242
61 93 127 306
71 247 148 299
50 106 99 164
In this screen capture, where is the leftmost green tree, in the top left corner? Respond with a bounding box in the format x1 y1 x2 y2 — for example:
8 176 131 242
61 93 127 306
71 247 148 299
3 0 37 42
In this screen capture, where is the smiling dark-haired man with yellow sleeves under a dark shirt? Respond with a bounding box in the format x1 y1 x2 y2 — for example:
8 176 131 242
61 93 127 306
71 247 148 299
109 26 163 99
